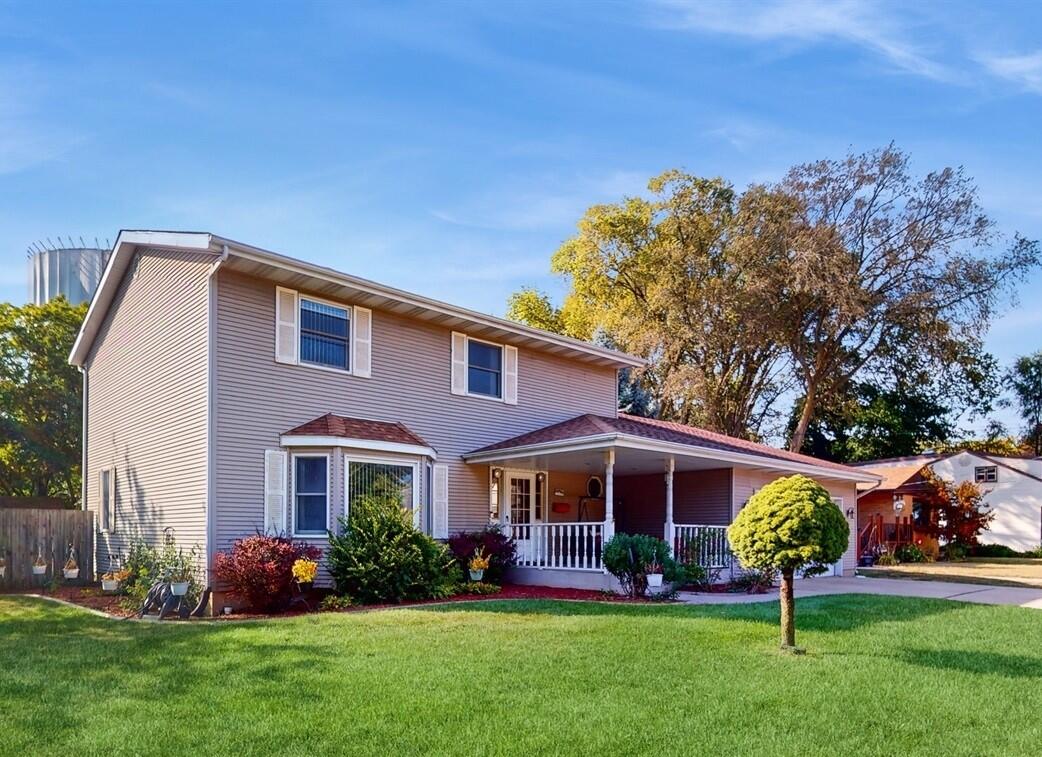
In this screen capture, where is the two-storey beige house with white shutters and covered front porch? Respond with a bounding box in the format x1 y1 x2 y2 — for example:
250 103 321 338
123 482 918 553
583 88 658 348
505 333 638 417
71 231 877 600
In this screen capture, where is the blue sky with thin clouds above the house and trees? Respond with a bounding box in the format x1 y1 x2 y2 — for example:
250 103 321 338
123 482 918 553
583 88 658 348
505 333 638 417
0 0 1042 435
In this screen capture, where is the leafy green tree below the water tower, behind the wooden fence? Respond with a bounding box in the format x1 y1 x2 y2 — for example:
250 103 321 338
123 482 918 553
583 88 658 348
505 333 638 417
0 297 86 507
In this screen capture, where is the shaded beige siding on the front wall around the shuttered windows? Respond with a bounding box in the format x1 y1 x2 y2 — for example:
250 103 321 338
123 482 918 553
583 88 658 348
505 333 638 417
215 271 616 548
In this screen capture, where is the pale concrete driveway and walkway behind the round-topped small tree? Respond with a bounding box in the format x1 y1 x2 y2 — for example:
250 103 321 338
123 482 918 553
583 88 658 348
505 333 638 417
678 578 1042 610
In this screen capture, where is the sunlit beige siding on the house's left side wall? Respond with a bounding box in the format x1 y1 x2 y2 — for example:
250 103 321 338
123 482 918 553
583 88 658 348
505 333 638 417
85 249 214 570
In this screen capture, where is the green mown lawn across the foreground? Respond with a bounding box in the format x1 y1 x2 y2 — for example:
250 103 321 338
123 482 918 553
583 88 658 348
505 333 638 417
0 595 1042 757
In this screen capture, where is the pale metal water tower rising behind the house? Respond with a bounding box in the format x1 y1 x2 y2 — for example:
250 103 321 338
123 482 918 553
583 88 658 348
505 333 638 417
26 237 108 304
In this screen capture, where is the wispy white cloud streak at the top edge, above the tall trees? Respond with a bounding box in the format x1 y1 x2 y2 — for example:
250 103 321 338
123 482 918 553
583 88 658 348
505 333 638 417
654 0 958 81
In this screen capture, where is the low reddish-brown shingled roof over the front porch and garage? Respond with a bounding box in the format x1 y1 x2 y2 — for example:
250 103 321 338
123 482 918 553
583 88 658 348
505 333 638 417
464 413 878 481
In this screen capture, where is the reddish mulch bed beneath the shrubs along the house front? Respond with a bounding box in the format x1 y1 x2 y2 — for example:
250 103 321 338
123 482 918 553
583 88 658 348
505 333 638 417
10 584 651 620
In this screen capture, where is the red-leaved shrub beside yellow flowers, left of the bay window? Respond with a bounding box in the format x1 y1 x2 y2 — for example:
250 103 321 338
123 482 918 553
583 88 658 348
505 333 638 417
214 534 322 612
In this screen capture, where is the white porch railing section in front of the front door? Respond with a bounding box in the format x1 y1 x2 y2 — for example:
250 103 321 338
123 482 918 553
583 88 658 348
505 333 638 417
506 522 604 570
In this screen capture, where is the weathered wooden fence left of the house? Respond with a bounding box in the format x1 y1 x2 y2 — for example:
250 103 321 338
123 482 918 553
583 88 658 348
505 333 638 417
0 509 94 591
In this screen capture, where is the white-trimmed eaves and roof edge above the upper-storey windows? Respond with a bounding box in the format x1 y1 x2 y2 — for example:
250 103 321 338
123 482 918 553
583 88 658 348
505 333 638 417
69 230 645 368
